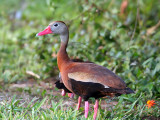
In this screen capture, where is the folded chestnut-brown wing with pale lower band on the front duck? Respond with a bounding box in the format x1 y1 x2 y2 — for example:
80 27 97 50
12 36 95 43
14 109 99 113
67 63 126 89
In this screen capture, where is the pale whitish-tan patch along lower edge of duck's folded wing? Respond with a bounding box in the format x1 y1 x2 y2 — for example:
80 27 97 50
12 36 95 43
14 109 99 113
68 72 109 88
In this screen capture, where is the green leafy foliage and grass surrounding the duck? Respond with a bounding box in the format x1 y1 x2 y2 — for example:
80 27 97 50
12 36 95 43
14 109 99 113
0 0 160 120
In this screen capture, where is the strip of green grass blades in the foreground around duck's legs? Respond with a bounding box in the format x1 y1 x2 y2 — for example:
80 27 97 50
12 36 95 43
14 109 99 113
0 94 160 120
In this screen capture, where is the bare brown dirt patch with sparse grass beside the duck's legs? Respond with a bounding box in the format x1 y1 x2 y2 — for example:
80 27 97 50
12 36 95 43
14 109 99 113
0 78 118 109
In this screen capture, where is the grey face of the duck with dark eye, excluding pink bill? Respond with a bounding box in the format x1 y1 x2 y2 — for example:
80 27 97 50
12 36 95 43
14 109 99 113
49 21 68 35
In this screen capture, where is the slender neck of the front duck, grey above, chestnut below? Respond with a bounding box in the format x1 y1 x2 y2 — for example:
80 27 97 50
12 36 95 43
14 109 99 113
57 32 70 72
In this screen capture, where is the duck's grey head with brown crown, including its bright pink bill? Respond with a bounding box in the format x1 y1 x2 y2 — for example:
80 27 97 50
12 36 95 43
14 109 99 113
36 21 68 36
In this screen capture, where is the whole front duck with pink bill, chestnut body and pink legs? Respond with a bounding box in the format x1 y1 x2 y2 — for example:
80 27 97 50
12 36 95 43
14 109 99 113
37 21 134 120
